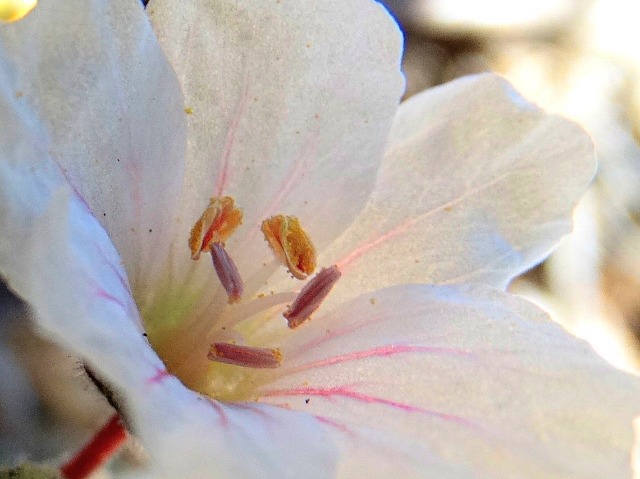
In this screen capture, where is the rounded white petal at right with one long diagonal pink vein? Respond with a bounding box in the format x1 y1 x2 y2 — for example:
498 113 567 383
319 74 594 298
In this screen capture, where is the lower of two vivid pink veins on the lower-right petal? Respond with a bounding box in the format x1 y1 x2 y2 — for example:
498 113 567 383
263 386 476 428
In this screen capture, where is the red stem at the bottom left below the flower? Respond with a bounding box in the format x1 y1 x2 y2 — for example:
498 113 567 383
60 414 127 479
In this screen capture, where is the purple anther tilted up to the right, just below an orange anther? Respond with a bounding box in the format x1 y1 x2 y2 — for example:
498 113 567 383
283 265 342 329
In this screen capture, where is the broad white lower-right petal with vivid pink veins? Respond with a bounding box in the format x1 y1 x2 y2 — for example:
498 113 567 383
262 285 640 478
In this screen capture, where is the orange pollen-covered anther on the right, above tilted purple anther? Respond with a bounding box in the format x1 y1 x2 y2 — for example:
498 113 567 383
262 215 316 279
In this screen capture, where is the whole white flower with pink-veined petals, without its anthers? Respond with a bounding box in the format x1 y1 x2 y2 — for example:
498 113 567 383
0 0 640 479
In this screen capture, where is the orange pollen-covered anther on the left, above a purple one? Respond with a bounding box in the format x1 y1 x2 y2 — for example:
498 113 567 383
189 196 242 259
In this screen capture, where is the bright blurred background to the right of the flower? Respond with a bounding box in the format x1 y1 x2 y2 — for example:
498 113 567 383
387 0 640 372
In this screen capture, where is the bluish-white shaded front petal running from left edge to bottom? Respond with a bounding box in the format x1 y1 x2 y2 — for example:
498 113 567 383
0 88 336 479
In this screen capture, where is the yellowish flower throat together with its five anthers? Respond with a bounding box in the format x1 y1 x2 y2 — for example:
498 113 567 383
142 196 341 401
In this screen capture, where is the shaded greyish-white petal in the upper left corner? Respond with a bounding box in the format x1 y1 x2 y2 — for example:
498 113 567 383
0 0 186 296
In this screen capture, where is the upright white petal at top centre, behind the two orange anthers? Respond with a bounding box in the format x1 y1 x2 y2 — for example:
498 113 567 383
147 0 404 283
